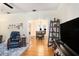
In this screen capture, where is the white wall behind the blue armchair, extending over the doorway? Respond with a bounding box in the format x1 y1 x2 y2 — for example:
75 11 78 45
0 11 56 40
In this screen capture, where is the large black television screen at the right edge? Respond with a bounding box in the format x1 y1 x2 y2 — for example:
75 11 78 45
60 17 79 54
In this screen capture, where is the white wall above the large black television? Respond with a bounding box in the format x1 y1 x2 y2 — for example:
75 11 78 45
56 3 79 23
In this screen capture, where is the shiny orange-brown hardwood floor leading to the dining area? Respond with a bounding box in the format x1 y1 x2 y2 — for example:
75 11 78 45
21 38 54 56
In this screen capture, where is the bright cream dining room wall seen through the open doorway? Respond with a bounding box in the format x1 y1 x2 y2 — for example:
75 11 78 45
29 19 48 37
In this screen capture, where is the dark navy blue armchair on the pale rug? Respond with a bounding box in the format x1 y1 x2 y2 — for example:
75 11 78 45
7 31 21 49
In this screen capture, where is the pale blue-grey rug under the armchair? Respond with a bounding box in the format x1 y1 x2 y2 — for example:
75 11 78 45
0 42 29 56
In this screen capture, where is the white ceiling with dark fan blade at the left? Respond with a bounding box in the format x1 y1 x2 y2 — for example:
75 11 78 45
0 3 60 14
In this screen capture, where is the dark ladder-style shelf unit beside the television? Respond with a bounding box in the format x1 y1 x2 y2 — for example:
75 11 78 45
48 18 60 47
